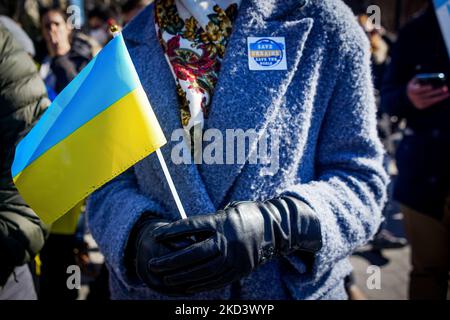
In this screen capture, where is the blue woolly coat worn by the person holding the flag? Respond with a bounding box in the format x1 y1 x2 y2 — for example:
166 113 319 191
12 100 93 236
87 0 388 299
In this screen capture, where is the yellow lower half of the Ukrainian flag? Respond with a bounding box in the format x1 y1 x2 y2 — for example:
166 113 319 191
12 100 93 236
14 87 166 223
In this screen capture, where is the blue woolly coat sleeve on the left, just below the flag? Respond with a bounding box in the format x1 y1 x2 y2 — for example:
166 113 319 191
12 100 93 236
87 168 163 286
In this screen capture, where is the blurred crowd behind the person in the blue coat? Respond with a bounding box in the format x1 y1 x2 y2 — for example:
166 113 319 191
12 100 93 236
0 0 450 299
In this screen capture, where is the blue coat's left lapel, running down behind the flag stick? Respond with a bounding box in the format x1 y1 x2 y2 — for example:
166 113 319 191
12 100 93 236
123 5 215 218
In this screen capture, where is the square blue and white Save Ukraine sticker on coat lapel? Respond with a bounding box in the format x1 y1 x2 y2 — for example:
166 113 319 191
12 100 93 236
247 37 287 71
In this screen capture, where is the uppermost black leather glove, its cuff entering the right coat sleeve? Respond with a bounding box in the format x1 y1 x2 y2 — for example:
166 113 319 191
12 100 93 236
148 196 322 294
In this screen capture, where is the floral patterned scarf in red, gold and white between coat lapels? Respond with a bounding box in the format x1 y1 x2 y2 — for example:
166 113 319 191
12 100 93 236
155 0 241 138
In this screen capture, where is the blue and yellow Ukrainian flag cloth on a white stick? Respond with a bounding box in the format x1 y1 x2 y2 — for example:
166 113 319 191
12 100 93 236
11 31 166 224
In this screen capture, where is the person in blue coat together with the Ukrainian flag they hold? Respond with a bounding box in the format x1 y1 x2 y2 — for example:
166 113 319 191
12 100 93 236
11 0 388 299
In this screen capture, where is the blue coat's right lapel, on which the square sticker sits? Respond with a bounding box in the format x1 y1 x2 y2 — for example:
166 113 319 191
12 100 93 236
199 0 313 207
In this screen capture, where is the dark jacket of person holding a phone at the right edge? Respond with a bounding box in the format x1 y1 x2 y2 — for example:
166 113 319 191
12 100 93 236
381 7 450 219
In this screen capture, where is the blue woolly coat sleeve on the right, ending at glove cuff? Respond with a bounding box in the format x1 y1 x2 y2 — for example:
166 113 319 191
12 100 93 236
286 34 388 279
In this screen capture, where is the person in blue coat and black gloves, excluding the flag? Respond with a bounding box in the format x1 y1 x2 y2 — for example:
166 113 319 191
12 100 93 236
82 0 388 299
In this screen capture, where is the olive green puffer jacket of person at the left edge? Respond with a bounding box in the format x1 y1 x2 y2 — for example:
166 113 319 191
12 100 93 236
0 26 49 286
